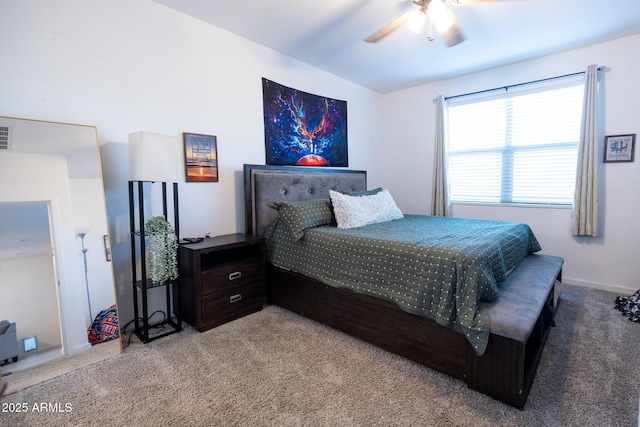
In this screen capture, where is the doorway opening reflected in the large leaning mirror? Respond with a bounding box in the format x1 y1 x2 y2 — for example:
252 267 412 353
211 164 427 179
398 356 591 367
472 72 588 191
0 202 63 370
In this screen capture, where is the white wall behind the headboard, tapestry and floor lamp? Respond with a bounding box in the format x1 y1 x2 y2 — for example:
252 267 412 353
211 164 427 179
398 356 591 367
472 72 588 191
0 0 383 322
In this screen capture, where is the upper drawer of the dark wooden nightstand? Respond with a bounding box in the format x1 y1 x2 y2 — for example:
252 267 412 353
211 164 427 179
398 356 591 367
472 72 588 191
202 259 265 296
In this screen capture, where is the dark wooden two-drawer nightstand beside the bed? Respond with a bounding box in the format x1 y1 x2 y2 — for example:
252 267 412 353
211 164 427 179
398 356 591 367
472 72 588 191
178 234 266 331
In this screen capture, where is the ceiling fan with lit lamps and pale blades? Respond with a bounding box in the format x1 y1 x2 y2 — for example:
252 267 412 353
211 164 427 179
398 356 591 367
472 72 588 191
364 0 508 47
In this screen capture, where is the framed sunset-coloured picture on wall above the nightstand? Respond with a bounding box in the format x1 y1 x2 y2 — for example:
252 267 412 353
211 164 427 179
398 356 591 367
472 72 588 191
183 132 218 182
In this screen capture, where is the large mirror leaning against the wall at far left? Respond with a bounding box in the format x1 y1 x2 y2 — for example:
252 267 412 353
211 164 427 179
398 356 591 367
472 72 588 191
0 117 122 386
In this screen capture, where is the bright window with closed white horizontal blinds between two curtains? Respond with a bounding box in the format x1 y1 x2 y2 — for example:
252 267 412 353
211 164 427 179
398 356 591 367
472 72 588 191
447 75 584 205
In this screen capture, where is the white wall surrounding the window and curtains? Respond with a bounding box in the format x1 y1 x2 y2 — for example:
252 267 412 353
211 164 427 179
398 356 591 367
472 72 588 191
383 35 640 293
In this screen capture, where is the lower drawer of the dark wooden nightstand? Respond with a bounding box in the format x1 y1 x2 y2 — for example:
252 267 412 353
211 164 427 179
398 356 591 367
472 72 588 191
202 282 264 327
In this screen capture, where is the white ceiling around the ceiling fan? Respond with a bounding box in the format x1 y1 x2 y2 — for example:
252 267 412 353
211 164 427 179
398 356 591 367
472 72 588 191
155 0 640 93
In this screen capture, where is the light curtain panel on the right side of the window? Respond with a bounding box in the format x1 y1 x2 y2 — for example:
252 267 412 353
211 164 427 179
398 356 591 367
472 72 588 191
571 65 599 236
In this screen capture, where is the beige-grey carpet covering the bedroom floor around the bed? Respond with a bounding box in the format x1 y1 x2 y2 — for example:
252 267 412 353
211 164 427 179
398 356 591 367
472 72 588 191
0 286 640 427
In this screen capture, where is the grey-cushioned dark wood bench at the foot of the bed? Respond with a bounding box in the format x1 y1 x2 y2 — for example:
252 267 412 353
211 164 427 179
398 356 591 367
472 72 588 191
467 254 564 408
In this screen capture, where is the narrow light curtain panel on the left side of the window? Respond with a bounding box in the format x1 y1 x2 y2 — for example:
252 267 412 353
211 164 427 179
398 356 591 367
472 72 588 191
431 95 449 216
